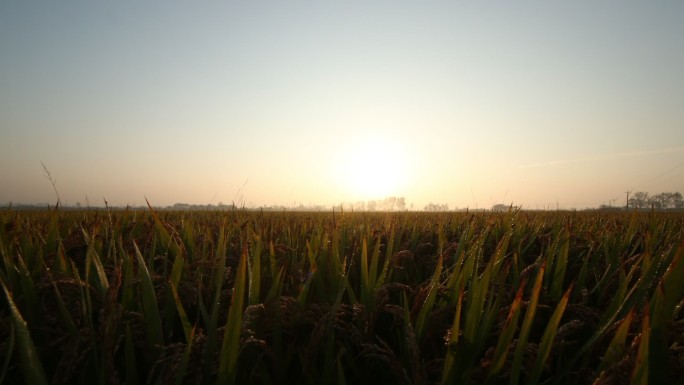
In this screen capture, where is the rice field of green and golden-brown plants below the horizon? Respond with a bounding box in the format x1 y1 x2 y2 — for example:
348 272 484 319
0 208 684 385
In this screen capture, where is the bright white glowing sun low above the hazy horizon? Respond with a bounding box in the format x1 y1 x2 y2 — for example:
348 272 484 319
335 137 406 200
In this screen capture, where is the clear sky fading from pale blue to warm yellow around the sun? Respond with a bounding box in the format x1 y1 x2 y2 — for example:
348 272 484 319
0 0 684 209
